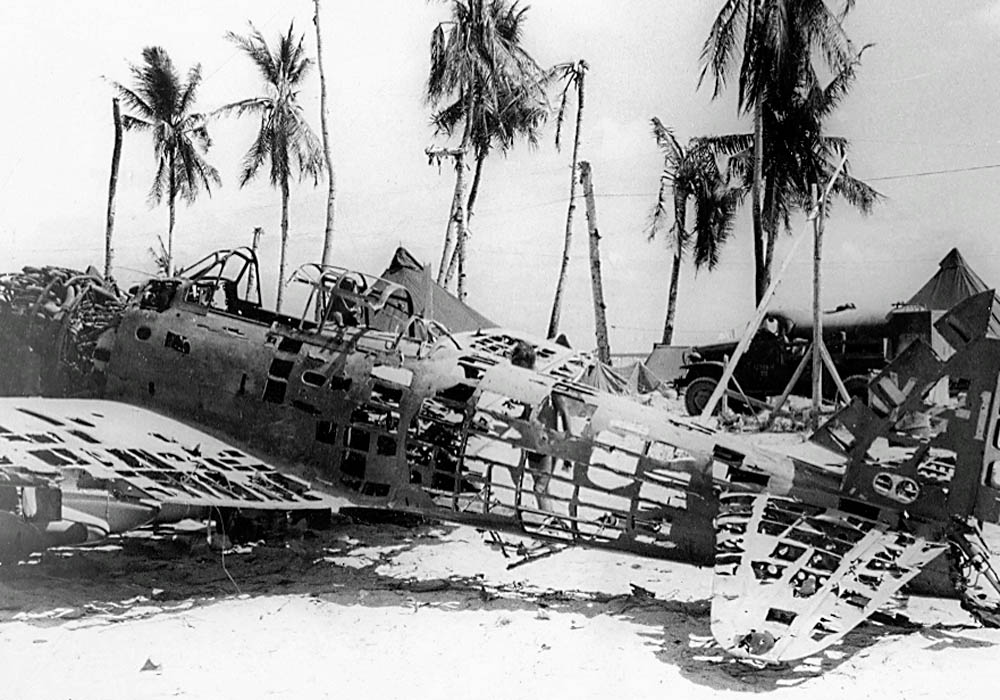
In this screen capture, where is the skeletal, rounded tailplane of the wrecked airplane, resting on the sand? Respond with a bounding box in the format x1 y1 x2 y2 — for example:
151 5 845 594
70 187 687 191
712 492 947 662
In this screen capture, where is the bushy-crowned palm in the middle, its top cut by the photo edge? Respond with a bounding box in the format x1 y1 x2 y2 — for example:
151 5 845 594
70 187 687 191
426 0 542 299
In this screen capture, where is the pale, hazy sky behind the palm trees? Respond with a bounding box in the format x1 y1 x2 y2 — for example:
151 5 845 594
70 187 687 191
0 0 1000 353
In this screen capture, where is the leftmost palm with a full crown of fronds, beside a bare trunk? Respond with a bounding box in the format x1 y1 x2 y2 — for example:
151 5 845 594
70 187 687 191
112 46 221 274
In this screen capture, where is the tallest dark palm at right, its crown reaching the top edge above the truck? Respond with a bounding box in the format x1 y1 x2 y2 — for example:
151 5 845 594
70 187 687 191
699 0 855 301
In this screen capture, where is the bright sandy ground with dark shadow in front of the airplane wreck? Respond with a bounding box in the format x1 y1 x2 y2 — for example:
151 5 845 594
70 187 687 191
0 504 1000 700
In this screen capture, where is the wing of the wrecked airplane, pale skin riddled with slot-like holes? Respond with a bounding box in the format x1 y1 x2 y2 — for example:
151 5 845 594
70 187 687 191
0 398 329 535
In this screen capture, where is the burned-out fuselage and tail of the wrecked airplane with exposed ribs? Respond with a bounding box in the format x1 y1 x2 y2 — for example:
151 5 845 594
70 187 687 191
0 249 1000 662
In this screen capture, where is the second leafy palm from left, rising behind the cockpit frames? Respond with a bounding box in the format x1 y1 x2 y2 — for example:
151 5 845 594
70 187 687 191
218 24 323 311
